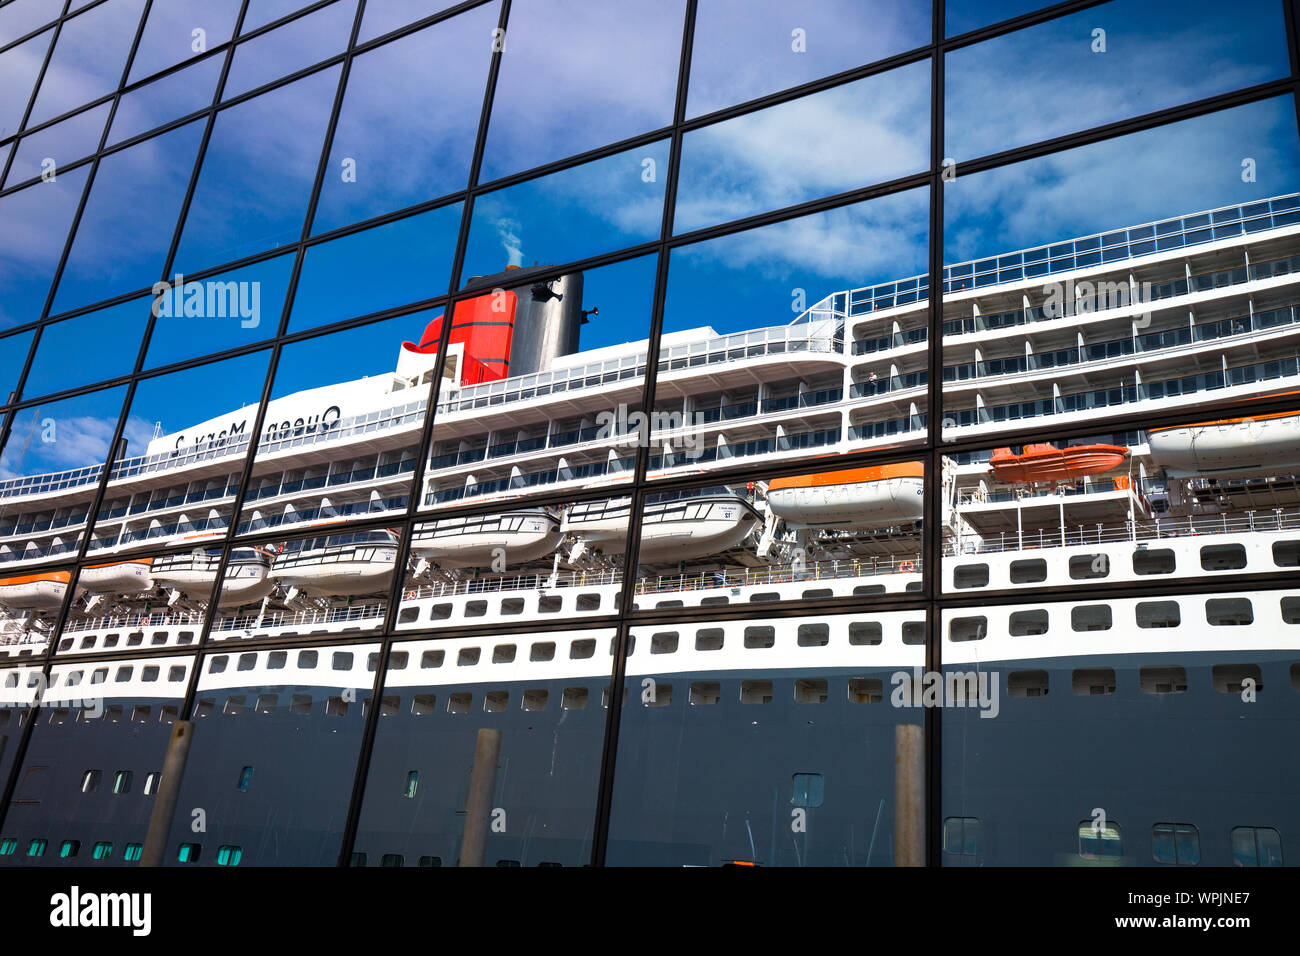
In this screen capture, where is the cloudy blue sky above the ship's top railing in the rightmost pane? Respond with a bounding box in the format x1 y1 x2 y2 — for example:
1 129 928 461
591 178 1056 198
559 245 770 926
944 96 1300 264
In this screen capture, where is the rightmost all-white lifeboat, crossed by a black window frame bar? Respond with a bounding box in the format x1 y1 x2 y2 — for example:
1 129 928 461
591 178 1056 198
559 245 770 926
564 492 761 563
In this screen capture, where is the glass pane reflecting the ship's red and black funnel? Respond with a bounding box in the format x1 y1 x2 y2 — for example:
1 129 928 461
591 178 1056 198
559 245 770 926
418 256 657 506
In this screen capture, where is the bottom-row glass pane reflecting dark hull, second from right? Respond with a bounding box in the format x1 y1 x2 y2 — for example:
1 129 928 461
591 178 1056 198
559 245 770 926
607 611 924 866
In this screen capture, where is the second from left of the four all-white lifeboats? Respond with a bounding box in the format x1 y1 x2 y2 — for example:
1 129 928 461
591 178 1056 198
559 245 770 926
270 531 398 597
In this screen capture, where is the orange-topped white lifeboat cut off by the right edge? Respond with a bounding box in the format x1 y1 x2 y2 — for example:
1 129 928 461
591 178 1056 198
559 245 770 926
1147 411 1300 477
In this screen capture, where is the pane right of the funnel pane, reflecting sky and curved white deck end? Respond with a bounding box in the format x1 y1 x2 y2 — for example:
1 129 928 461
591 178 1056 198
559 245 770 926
665 190 927 468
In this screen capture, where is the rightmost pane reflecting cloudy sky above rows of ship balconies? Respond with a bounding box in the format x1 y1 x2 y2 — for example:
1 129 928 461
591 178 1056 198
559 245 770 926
946 96 1300 447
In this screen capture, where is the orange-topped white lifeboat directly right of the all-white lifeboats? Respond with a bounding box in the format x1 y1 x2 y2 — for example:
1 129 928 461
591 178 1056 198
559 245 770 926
767 462 926 528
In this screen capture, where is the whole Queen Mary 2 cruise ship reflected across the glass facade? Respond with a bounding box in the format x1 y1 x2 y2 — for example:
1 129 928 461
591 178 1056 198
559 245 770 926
0 195 1300 865
